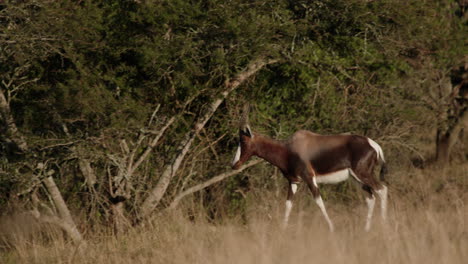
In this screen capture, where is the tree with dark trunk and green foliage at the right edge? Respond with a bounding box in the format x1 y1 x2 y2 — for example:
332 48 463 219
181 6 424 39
390 1 468 166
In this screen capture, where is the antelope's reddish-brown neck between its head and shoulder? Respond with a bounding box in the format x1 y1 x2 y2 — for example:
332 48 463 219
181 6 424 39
255 135 288 171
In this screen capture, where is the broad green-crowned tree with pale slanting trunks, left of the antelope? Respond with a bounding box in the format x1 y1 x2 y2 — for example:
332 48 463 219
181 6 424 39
1 1 288 229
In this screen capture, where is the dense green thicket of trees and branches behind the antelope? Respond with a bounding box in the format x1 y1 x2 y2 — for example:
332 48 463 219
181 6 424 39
0 0 468 243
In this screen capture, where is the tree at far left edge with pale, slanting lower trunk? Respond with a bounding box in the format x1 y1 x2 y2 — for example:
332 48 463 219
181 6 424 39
0 2 88 243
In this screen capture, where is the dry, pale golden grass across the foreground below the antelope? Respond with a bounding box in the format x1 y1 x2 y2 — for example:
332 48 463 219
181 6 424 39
0 166 468 264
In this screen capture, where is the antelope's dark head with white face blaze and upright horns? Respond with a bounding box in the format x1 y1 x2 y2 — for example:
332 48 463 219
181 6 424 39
231 105 254 170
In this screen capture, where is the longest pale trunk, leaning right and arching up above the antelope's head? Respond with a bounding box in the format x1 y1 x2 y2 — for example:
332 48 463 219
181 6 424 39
140 58 277 219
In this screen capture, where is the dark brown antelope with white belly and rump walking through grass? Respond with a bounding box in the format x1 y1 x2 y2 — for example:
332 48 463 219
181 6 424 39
232 109 387 232
